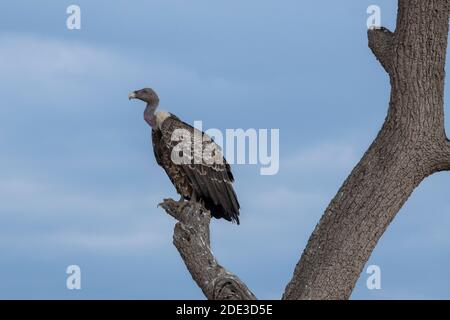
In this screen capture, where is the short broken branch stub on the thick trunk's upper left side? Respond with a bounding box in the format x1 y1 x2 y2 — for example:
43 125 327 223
367 27 394 74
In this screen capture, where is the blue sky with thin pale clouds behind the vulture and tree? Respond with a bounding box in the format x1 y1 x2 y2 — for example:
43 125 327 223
0 0 450 299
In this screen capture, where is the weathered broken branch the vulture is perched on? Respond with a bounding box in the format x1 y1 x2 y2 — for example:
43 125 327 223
159 199 256 300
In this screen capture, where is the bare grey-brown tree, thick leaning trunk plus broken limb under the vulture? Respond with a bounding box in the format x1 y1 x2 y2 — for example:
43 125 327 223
161 0 450 299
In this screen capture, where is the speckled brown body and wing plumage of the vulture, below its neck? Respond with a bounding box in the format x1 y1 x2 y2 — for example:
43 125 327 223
152 115 240 224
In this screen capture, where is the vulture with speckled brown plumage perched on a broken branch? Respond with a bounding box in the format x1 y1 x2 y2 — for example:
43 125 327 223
128 88 240 224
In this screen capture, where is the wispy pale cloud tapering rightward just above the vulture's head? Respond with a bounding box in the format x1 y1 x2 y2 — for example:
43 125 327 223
0 33 245 108
